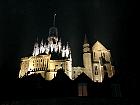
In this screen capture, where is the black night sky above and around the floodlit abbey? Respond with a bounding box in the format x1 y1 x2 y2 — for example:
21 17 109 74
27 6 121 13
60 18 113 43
0 0 137 79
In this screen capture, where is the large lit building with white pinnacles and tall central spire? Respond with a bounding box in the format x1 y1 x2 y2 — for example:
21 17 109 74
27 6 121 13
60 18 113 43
19 15 72 80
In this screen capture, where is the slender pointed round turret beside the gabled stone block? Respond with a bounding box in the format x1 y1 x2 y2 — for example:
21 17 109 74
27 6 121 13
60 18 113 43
83 35 93 80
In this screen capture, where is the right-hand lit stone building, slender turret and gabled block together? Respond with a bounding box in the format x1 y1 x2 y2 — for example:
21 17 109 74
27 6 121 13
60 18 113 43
83 37 115 82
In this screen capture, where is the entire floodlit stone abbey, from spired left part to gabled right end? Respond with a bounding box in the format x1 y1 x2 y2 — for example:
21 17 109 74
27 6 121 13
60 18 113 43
19 16 115 82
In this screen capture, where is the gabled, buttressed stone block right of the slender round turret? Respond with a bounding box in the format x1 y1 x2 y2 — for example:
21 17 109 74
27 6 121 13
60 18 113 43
92 41 114 82
